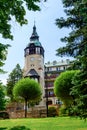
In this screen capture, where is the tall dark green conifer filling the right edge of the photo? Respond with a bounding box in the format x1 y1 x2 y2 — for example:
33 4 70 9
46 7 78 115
56 0 87 118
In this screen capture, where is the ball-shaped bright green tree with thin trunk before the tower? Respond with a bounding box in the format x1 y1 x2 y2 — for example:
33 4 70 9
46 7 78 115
13 78 41 118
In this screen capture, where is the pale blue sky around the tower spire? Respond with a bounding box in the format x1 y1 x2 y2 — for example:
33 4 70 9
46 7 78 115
0 0 69 84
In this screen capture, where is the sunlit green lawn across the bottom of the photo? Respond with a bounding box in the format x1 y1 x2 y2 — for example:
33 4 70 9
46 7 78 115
0 117 87 130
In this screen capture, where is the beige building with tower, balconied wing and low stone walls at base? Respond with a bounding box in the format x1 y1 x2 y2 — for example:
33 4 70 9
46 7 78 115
7 25 70 118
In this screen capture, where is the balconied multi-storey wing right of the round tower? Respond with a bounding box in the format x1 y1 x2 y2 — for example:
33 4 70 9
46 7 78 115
44 59 70 105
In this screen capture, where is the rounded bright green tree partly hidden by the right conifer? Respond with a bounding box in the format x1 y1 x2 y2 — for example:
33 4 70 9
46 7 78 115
54 70 77 107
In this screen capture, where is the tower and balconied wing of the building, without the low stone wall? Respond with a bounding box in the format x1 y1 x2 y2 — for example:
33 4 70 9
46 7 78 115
24 25 69 107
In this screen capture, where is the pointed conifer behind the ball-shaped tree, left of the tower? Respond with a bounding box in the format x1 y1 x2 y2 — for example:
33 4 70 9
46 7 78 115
7 64 23 101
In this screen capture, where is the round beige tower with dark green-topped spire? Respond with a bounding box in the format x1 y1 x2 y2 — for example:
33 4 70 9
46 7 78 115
24 24 44 106
